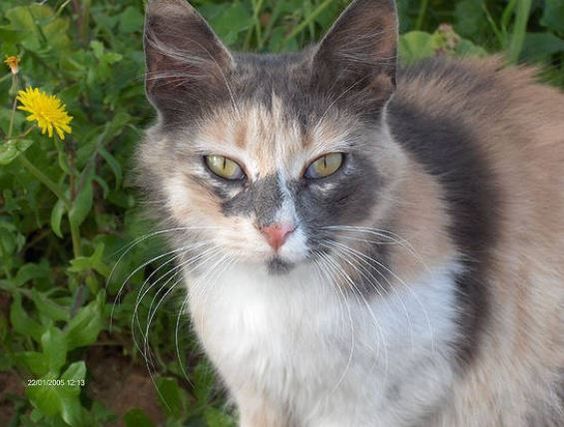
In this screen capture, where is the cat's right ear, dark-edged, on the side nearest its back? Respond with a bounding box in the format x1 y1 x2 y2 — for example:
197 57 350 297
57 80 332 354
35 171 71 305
312 0 398 103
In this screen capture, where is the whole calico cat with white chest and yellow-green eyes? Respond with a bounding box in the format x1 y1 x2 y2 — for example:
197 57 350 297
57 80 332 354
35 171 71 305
138 0 564 427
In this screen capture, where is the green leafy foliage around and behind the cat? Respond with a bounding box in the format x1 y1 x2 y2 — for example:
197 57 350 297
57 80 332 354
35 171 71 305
0 0 564 426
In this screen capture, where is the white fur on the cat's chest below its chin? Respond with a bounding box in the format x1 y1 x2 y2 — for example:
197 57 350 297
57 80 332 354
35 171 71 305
187 262 458 427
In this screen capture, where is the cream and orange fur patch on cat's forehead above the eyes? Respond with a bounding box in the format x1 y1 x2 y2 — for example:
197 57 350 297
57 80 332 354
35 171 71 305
193 93 352 177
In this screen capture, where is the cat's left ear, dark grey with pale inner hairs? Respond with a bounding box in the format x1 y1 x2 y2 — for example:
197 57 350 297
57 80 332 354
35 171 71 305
144 0 234 119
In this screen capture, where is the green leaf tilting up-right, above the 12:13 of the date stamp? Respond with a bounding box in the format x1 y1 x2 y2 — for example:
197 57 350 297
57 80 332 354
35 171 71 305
65 292 105 351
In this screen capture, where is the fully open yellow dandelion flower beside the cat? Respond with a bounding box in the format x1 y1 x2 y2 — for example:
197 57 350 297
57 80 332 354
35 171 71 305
16 87 72 140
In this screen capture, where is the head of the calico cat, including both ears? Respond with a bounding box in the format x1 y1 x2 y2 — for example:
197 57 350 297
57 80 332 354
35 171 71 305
140 0 404 272
